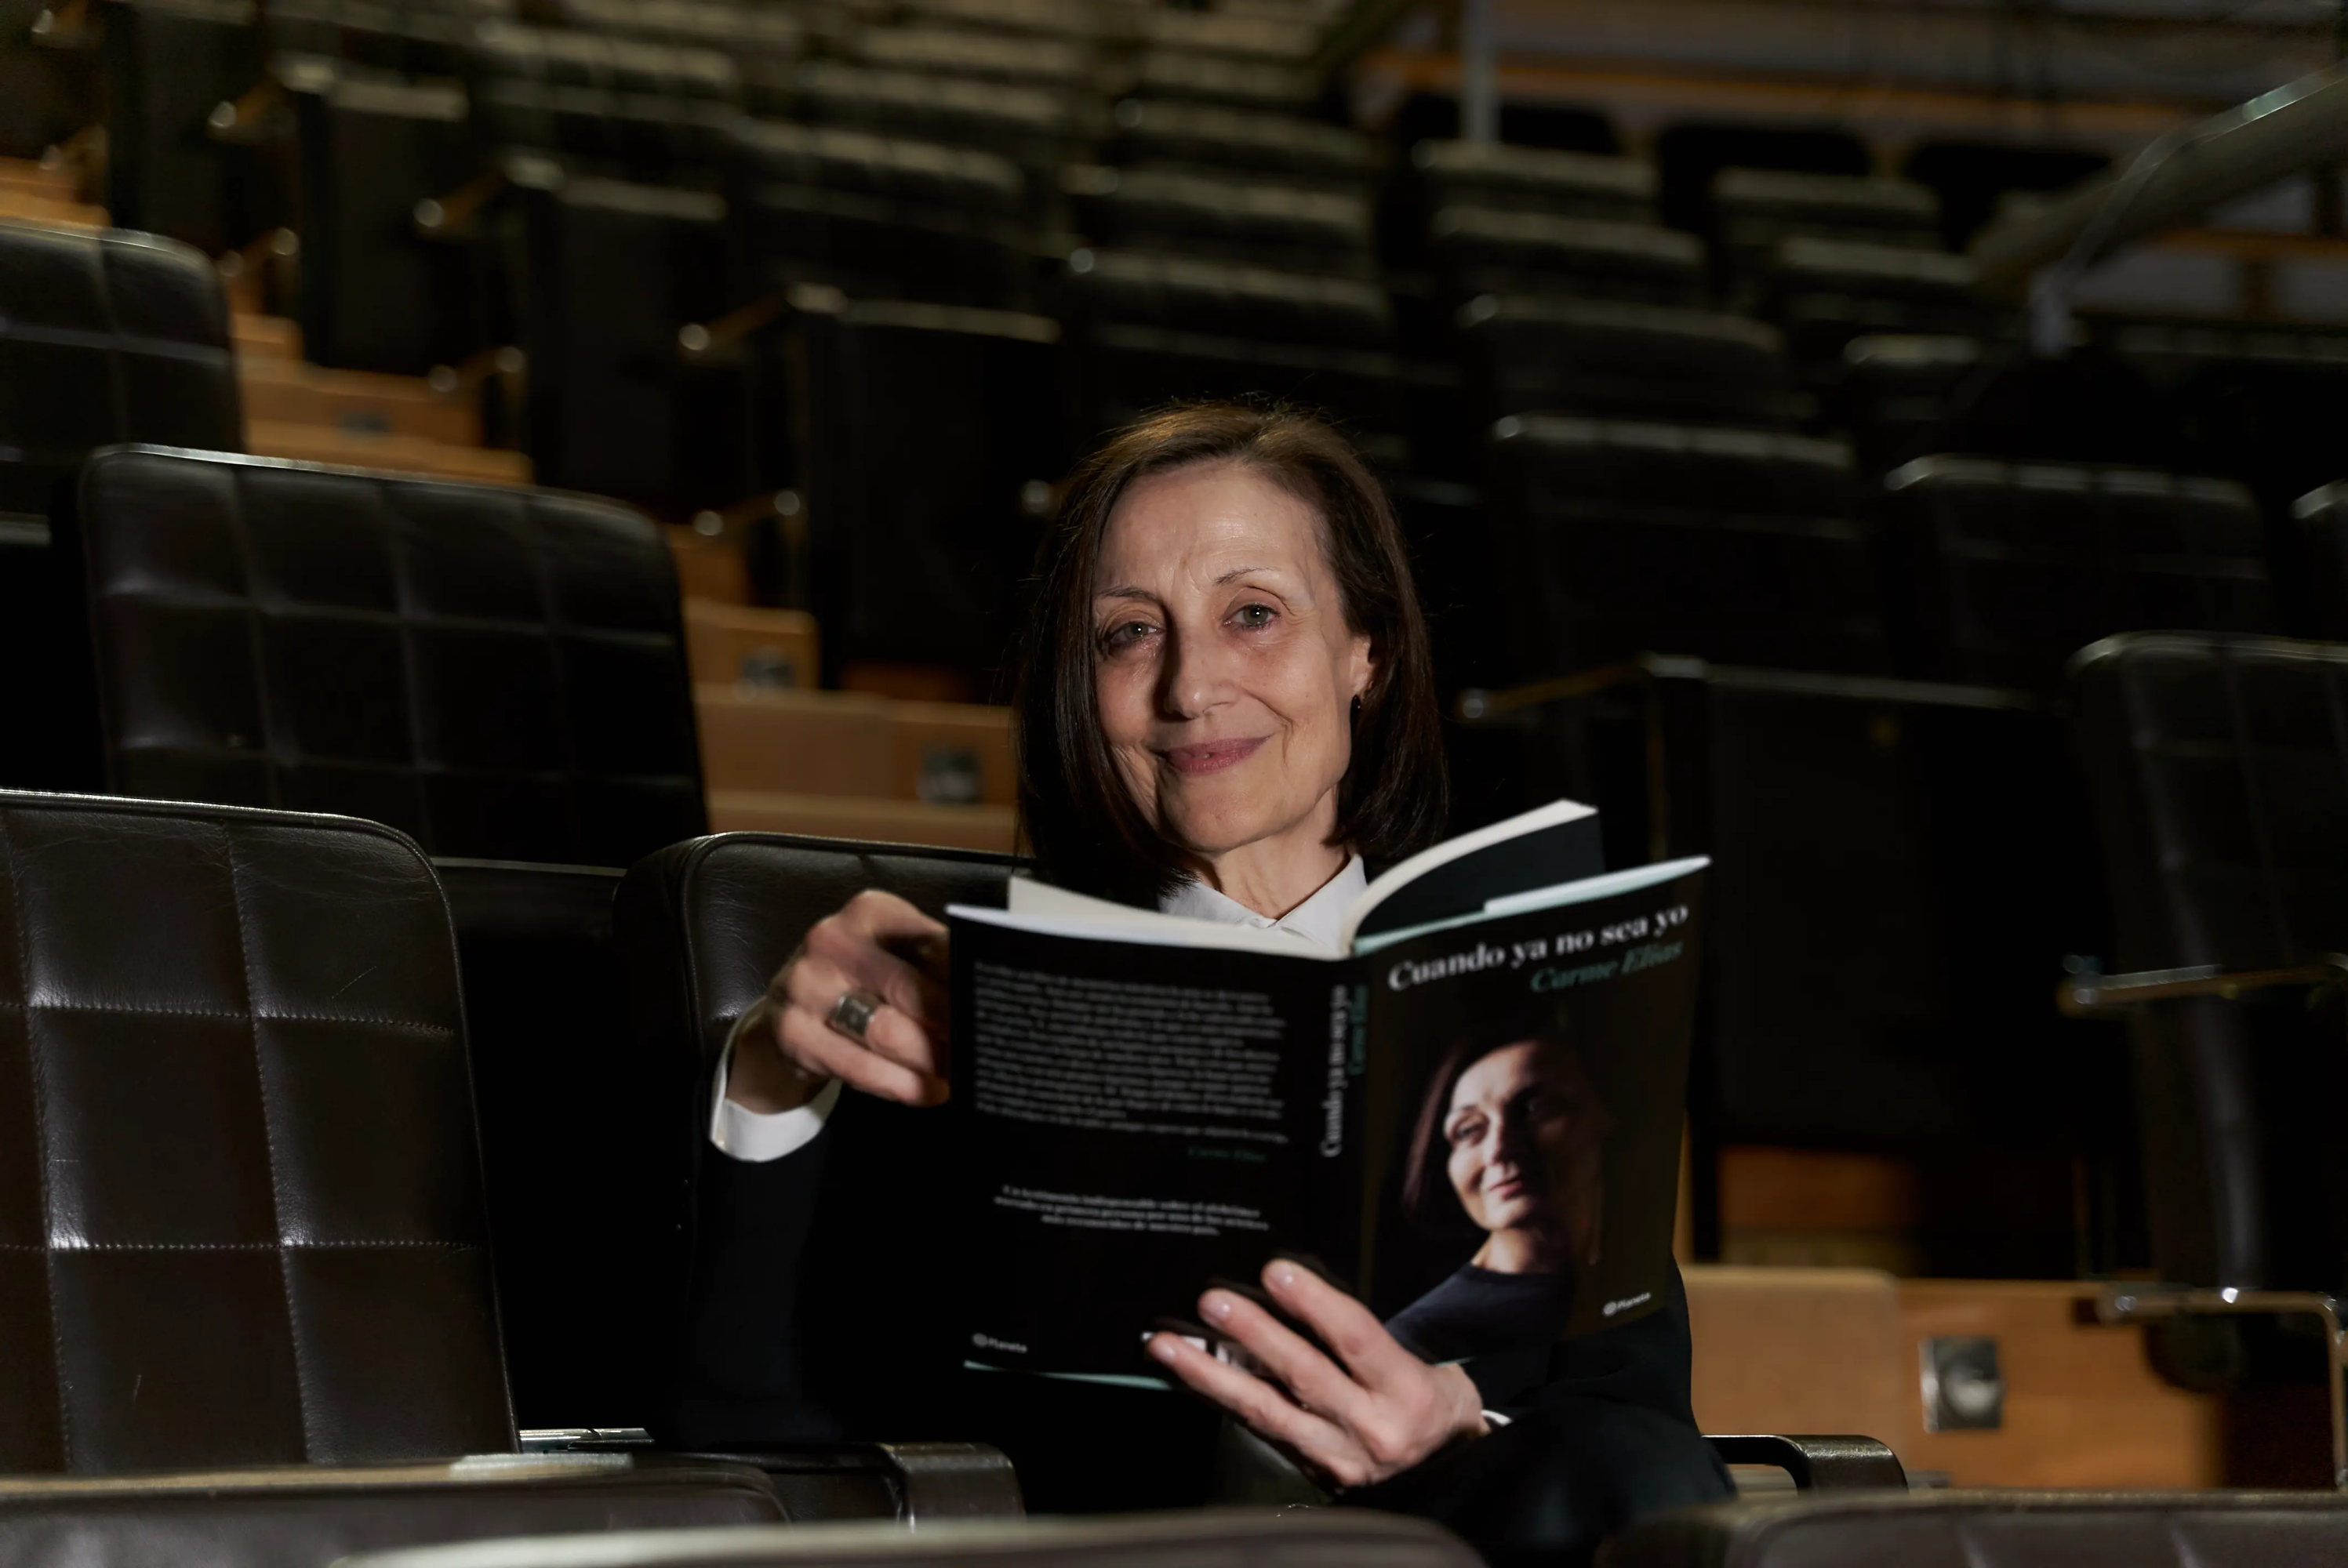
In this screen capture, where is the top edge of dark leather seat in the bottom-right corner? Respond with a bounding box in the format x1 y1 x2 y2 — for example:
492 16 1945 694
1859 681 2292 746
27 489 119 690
1597 1490 2348 1568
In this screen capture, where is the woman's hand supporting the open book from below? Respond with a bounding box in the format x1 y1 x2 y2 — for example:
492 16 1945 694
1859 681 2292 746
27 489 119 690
1148 1258 1486 1488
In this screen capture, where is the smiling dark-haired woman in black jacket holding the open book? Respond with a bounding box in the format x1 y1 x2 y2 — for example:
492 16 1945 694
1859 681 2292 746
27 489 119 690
671 404 1728 1561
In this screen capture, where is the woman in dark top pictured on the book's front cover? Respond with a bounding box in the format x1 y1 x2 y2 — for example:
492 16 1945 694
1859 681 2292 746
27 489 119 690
1385 1030 1608 1362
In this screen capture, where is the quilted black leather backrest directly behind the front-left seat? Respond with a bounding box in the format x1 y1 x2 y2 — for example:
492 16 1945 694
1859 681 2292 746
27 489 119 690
80 448 704 866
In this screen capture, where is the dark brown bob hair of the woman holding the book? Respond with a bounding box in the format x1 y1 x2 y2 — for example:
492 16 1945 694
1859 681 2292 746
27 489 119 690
1014 404 1448 904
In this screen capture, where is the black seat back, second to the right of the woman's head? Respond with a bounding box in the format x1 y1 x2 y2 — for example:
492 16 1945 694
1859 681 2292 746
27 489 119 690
1883 458 2275 690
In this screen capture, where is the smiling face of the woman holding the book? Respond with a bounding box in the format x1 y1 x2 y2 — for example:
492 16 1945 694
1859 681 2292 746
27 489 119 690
1092 463 1371 857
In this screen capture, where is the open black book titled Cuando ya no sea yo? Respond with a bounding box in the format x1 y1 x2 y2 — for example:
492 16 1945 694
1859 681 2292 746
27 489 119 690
949 800 1705 1382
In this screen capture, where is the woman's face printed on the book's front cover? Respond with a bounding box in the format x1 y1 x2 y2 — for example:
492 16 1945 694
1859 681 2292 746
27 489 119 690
1444 1040 1576 1230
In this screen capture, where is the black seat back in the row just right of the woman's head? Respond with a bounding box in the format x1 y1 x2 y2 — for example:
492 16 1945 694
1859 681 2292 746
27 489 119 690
1491 413 1890 676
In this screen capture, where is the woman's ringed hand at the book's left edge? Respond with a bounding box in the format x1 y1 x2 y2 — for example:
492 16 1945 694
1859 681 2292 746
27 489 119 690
725 890 947 1115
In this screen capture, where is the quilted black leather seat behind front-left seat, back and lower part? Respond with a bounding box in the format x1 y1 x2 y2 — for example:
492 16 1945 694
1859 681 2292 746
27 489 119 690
68 448 704 1427
